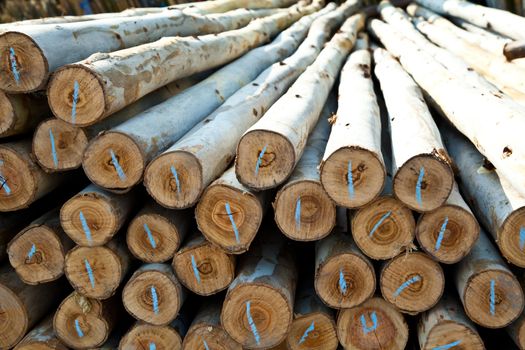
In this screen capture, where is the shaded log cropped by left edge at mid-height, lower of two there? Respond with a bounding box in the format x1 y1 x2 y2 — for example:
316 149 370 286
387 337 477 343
0 139 66 212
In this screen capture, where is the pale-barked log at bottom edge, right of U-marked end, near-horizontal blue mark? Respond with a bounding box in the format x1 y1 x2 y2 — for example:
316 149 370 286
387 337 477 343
417 294 485 350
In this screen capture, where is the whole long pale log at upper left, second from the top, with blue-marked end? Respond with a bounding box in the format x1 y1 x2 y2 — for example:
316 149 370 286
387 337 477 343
48 2 321 126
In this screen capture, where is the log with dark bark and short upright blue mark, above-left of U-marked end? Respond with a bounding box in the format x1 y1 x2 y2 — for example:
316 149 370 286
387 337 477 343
315 231 376 309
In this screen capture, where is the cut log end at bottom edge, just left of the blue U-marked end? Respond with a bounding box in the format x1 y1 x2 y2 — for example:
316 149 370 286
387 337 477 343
286 312 339 350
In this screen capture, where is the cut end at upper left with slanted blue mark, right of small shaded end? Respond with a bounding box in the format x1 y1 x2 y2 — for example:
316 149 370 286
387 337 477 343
82 132 145 192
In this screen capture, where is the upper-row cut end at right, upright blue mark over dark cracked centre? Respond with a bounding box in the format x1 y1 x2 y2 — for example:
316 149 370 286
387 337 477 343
394 154 454 212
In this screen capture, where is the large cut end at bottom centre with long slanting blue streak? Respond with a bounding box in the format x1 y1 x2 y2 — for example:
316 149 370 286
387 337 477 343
221 285 293 349
